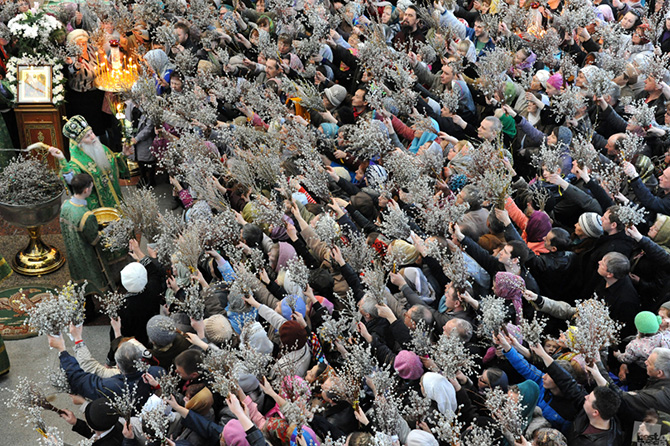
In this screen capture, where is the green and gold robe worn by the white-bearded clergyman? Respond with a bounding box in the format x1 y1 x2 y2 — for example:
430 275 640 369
59 140 128 210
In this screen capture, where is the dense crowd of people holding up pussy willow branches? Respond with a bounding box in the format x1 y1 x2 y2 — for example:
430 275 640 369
6 0 670 446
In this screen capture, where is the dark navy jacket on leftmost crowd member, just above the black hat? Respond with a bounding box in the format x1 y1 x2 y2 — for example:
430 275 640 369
59 351 165 410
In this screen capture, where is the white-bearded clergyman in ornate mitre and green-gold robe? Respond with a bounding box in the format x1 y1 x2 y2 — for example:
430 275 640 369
49 115 132 210
